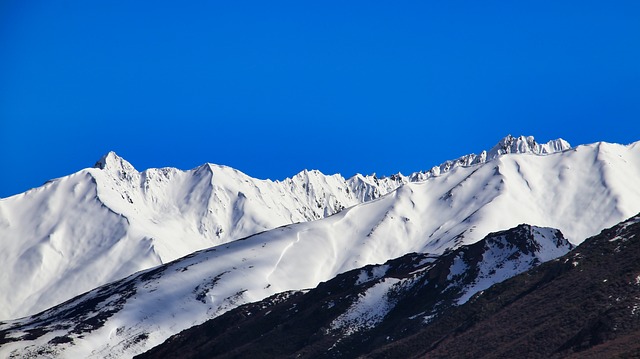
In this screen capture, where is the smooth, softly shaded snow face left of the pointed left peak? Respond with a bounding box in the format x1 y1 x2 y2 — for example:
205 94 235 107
0 171 160 326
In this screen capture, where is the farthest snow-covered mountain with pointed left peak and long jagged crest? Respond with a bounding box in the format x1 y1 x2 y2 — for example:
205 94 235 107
0 136 570 319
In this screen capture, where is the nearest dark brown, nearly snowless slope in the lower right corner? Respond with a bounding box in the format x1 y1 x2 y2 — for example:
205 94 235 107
367 216 640 358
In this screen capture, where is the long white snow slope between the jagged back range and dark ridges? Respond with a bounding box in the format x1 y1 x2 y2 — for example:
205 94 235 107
0 142 640 357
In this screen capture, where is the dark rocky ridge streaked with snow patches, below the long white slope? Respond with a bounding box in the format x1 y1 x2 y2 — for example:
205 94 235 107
137 225 573 359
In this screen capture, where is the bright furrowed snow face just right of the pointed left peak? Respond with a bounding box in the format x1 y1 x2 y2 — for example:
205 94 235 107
89 153 359 262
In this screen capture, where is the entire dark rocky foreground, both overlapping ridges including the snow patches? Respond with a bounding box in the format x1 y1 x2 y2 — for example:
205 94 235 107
136 214 640 359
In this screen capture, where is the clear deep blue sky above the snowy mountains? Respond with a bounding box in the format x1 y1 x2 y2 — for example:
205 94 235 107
0 0 640 197
